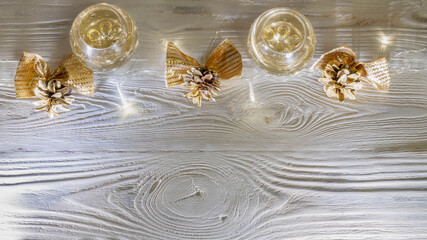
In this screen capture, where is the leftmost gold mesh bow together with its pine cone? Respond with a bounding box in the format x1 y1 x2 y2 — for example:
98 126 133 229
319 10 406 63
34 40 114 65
15 52 95 117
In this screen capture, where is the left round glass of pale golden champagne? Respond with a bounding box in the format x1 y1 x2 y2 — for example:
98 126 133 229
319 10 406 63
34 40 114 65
70 3 138 71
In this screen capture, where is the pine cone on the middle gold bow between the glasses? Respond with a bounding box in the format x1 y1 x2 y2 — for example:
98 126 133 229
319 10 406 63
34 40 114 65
182 67 220 107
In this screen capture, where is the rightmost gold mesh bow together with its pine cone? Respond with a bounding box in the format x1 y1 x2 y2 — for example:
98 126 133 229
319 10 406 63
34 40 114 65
311 46 390 101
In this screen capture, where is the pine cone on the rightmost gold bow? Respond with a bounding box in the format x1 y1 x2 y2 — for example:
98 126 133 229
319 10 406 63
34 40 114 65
319 61 362 102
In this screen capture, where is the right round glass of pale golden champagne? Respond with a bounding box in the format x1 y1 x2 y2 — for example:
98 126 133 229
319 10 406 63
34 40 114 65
248 8 316 75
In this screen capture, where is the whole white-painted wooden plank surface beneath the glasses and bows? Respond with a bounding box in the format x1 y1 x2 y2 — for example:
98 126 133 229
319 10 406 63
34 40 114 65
0 0 427 240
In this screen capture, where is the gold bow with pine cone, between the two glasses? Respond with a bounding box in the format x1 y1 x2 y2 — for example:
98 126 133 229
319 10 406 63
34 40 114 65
165 39 242 107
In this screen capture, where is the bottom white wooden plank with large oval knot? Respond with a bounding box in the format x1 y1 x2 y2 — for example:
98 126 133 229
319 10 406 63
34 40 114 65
2 151 427 239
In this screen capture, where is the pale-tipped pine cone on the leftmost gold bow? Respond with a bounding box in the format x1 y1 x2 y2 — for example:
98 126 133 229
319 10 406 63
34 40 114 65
33 79 74 118
